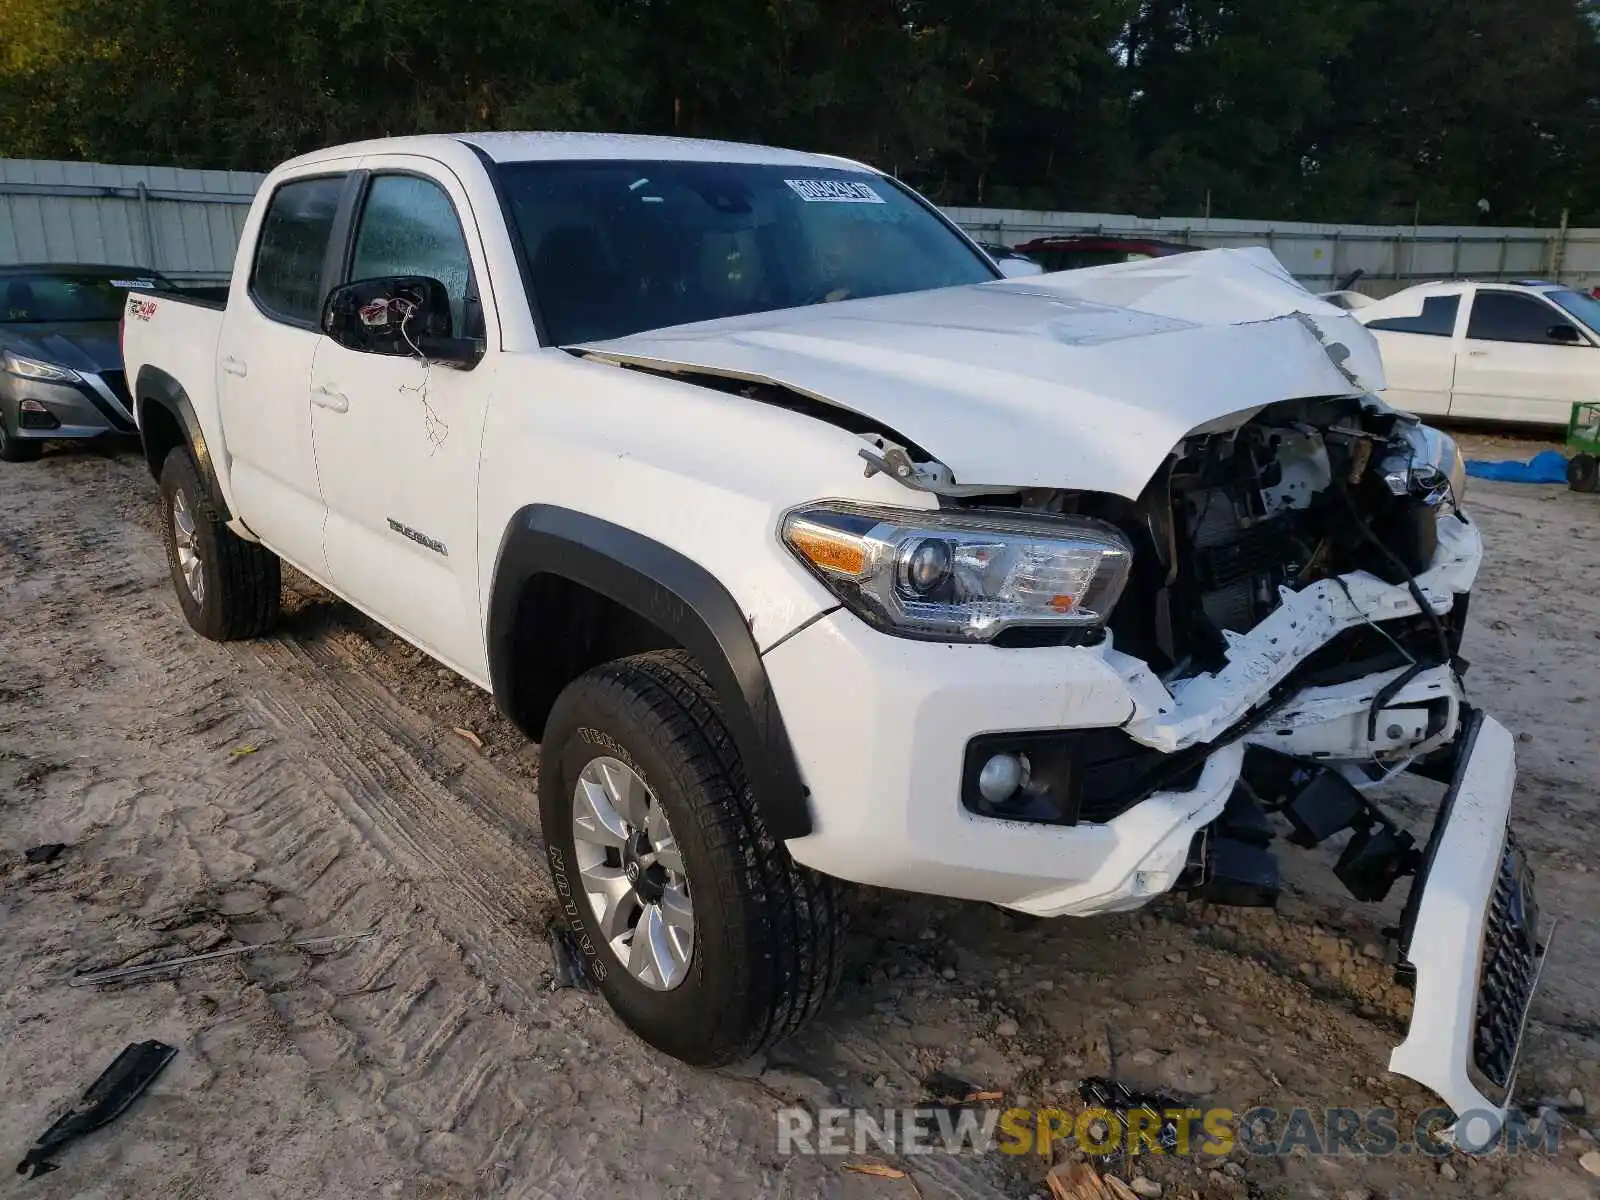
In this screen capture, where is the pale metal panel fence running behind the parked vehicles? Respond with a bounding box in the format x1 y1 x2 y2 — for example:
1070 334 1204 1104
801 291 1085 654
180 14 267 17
9 158 1600 296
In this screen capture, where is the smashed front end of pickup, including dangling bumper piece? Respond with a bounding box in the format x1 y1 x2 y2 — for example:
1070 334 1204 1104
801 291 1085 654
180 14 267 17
928 397 1544 1149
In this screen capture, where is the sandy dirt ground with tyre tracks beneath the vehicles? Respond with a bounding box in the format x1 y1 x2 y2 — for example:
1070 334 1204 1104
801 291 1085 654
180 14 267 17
0 438 1600 1200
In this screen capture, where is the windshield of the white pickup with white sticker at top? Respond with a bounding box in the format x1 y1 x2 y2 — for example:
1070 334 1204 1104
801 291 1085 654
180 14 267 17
499 160 995 346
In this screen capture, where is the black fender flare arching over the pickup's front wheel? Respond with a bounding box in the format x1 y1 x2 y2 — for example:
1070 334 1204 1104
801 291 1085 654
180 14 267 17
488 504 811 842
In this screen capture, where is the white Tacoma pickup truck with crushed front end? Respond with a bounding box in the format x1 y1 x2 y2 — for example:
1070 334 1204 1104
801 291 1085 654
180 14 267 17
125 134 1542 1141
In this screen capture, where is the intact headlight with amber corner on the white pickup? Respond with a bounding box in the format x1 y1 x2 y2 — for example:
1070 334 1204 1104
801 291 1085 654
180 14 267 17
781 502 1133 642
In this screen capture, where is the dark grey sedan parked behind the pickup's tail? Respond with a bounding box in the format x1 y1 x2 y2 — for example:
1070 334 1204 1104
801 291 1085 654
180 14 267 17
0 262 173 462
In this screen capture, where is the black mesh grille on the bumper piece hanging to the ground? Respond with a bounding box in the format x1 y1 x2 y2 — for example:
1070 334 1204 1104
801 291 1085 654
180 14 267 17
1472 829 1539 1090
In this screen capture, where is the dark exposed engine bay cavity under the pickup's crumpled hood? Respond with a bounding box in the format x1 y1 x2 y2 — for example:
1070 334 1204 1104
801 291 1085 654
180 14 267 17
955 397 1459 680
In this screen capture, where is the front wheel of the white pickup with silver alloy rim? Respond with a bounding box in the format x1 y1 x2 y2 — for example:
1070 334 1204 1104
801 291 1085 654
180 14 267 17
539 651 845 1067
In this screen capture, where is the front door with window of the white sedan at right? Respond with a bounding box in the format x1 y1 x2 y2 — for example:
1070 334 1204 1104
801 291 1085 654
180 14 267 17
1450 286 1600 426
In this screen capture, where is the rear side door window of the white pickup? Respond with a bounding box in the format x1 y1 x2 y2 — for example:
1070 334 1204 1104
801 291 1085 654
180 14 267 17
250 174 344 328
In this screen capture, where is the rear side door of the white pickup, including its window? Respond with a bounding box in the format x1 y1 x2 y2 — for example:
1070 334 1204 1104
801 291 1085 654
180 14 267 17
218 170 350 579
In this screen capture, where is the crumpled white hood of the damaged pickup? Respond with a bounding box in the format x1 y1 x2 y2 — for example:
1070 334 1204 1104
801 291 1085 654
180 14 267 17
568 248 1384 499
